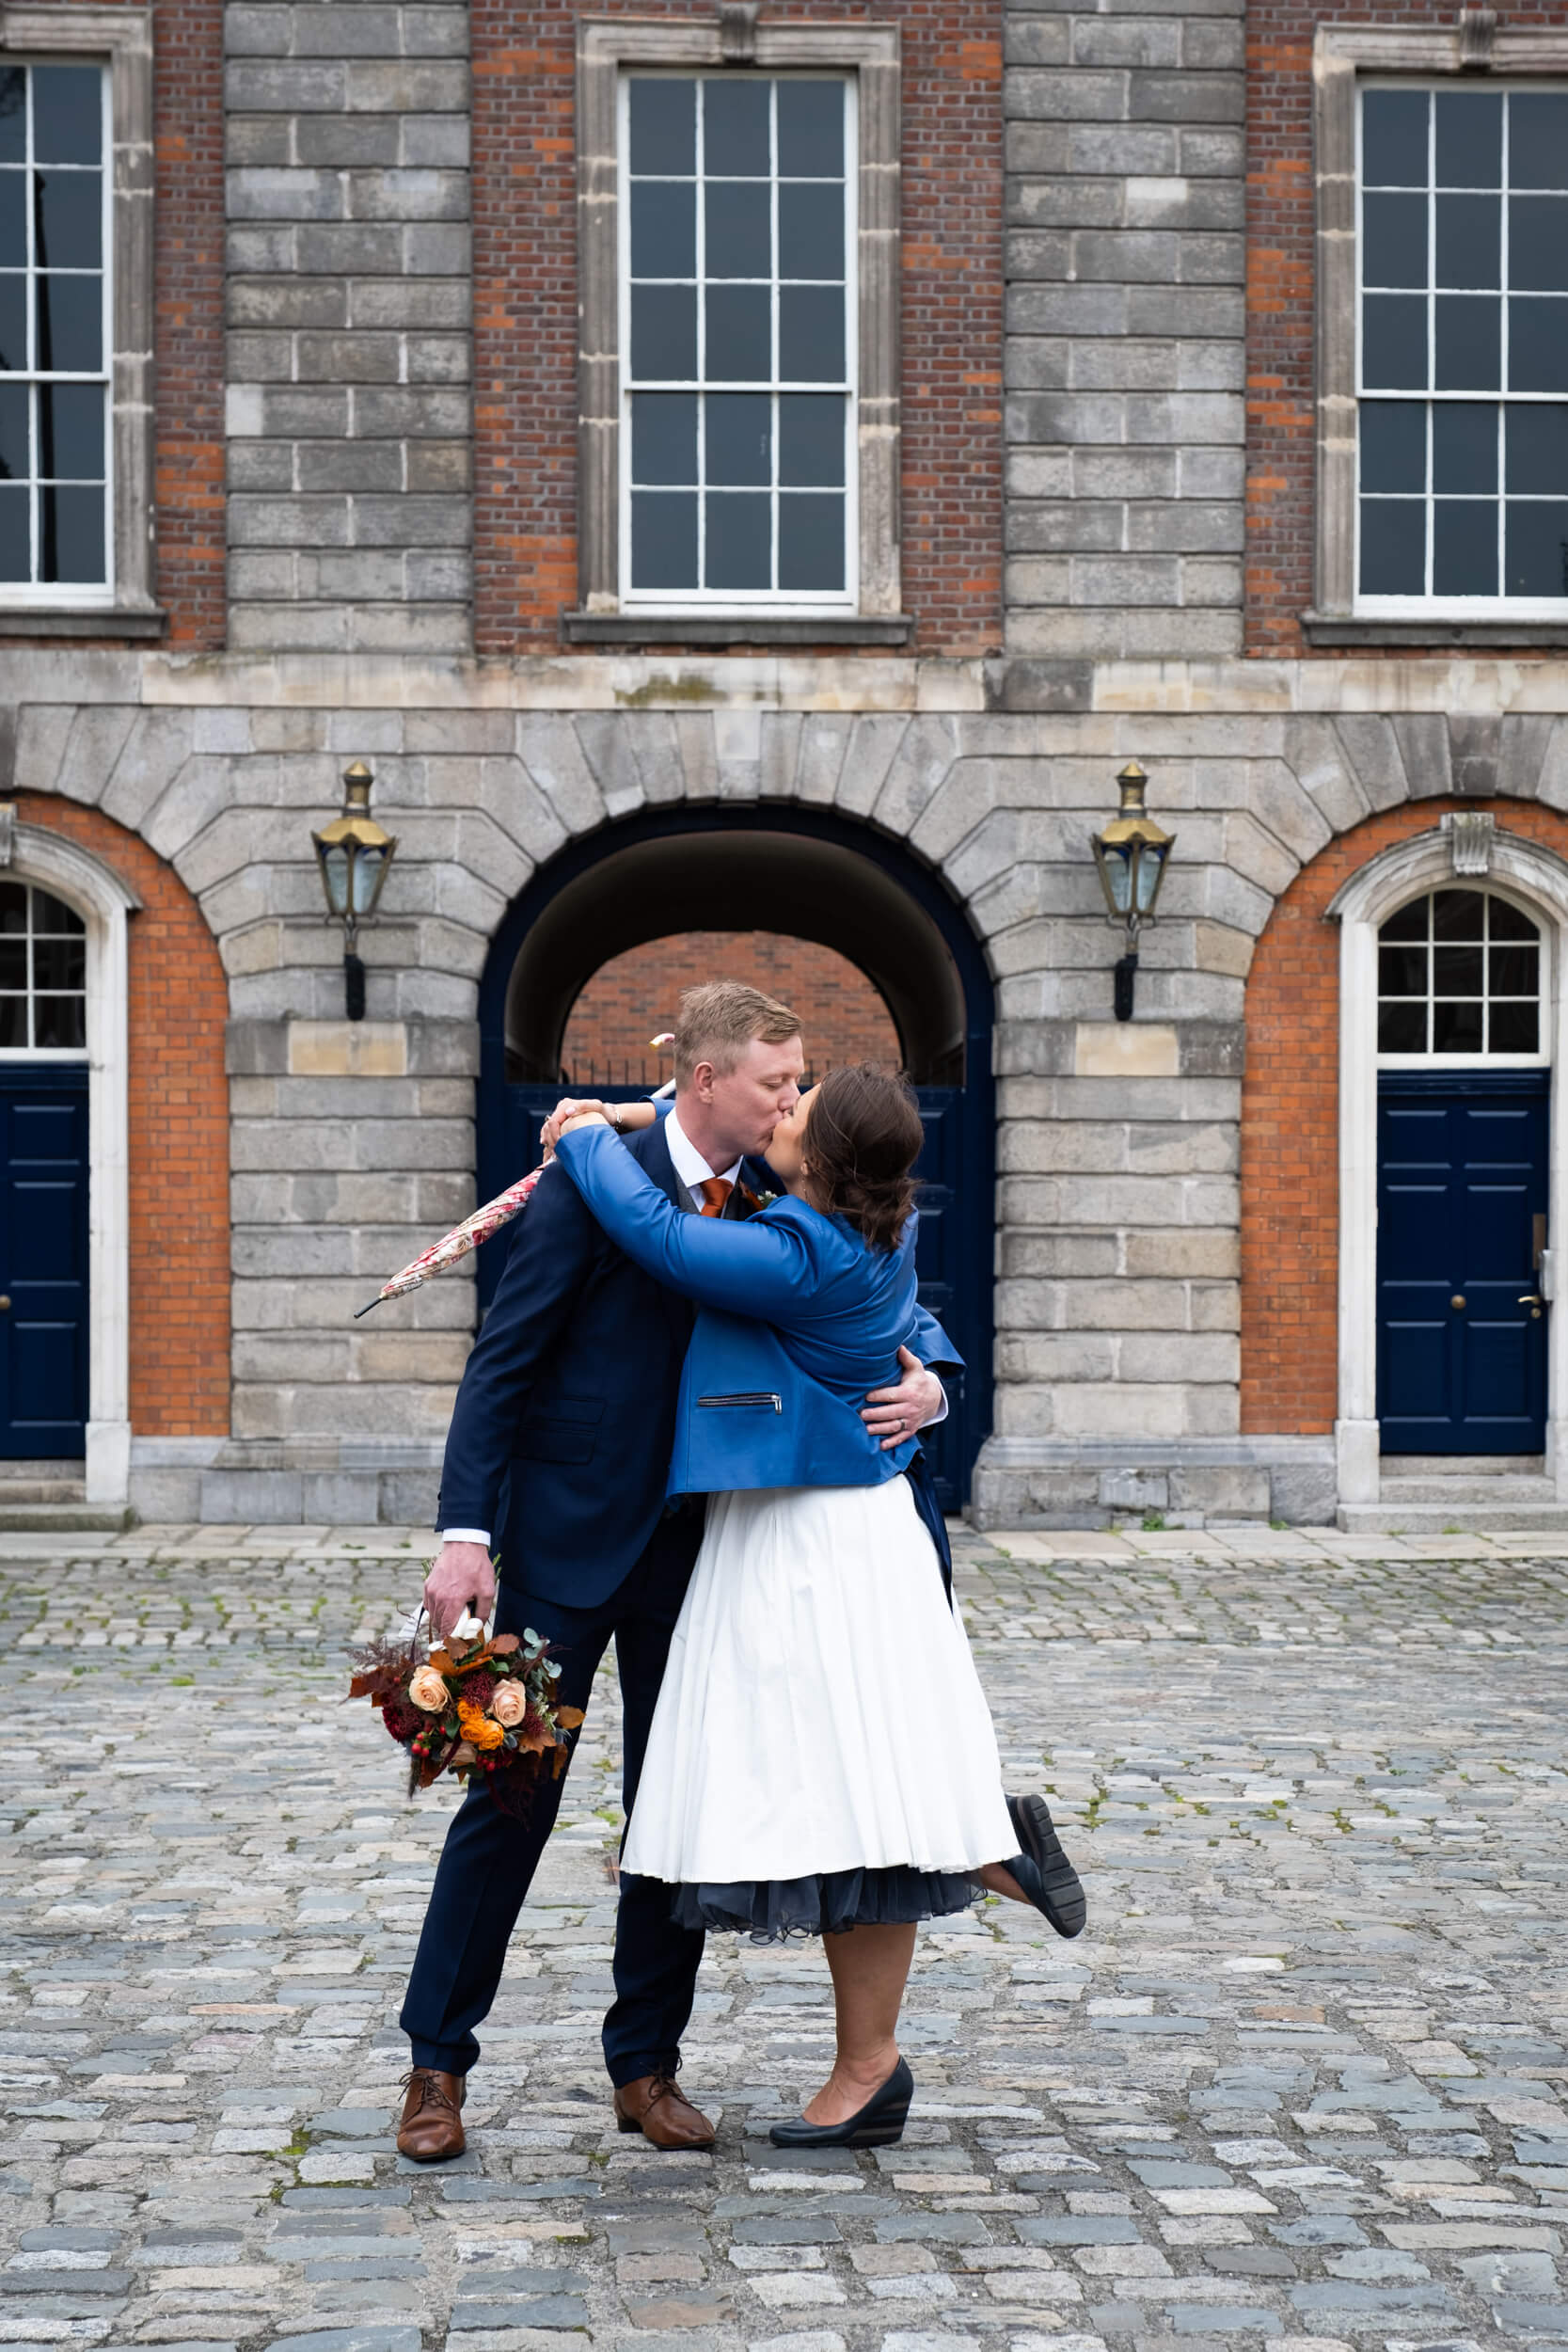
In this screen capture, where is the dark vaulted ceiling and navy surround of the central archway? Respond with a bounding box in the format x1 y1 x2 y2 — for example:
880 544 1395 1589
480 807 994 1508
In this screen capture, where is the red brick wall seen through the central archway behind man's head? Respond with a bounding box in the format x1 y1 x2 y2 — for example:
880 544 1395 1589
562 931 900 1085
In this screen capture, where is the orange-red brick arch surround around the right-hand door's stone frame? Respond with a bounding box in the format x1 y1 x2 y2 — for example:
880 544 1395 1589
1242 800 1568 1438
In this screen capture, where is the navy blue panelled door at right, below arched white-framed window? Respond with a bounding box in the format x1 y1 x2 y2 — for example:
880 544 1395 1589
1378 1071 1549 1454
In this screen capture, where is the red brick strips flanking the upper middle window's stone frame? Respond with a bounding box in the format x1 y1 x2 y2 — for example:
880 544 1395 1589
472 0 1002 654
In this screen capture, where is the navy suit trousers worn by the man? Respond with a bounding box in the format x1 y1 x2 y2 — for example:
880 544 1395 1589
402 1499 703 2087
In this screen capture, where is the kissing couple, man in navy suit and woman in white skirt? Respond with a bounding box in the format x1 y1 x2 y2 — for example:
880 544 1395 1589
397 981 1084 2164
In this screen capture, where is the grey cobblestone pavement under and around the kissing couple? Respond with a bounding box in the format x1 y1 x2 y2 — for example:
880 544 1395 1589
0 1529 1568 2352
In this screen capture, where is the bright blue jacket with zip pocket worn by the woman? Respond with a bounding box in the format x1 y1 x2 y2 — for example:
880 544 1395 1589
557 1127 961 1494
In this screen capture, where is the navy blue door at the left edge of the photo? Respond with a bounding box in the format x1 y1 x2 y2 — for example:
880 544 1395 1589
0 1063 87 1461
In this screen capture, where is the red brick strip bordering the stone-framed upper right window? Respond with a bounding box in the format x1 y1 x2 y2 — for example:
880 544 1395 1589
1246 0 1568 661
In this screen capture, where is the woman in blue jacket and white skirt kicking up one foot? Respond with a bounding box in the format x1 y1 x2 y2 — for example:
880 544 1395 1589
555 1066 1084 2148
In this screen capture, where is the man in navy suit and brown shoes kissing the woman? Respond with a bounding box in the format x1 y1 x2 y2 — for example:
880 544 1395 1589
397 981 947 2164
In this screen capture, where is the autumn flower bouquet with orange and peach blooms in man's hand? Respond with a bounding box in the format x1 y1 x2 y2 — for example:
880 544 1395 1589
348 1612 583 1814
